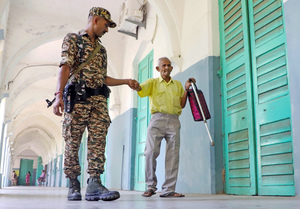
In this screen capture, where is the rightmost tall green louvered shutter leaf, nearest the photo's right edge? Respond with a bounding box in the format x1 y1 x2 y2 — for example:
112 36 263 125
249 0 295 195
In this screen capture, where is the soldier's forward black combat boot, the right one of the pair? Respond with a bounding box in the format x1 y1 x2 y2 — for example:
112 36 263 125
85 176 120 201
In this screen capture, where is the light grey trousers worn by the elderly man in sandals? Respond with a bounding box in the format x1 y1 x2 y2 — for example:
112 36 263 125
144 113 181 194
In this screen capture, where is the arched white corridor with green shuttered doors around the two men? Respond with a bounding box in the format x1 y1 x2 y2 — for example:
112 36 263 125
0 0 300 208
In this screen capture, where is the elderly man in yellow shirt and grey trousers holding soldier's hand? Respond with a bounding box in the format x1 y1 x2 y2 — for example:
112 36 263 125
135 57 195 197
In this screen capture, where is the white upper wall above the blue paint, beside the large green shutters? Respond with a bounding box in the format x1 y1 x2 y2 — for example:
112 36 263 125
181 0 220 71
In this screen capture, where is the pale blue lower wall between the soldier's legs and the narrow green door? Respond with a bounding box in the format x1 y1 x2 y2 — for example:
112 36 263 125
106 108 136 190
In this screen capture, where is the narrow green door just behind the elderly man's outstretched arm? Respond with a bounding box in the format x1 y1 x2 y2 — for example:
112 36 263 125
134 51 153 191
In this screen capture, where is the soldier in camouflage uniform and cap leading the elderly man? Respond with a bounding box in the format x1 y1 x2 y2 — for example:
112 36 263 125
53 7 136 200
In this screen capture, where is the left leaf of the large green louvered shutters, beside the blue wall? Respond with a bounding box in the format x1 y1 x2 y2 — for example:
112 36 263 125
219 0 256 195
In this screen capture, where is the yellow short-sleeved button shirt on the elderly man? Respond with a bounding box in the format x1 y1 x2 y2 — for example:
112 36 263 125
138 76 184 115
